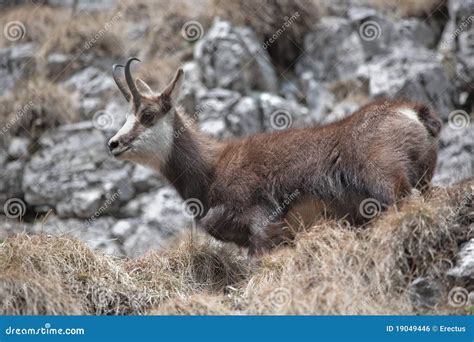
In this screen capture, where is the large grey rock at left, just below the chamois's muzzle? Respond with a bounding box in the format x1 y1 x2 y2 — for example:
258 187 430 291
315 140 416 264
23 123 134 218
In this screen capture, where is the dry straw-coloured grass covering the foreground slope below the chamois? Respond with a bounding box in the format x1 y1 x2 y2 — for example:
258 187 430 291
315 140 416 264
0 180 474 314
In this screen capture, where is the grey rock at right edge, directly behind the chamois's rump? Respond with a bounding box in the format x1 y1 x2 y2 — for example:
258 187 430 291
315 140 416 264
433 123 474 185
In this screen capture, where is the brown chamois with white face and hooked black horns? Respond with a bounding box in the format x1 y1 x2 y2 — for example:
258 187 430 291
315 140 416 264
108 58 441 256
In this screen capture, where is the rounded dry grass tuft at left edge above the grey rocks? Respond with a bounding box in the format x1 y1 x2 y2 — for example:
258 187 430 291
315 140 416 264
0 78 79 138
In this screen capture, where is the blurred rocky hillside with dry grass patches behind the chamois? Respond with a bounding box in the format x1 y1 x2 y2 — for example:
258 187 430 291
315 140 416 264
0 0 474 257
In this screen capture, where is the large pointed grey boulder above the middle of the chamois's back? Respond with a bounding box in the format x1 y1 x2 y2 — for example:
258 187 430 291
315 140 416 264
194 19 278 94
